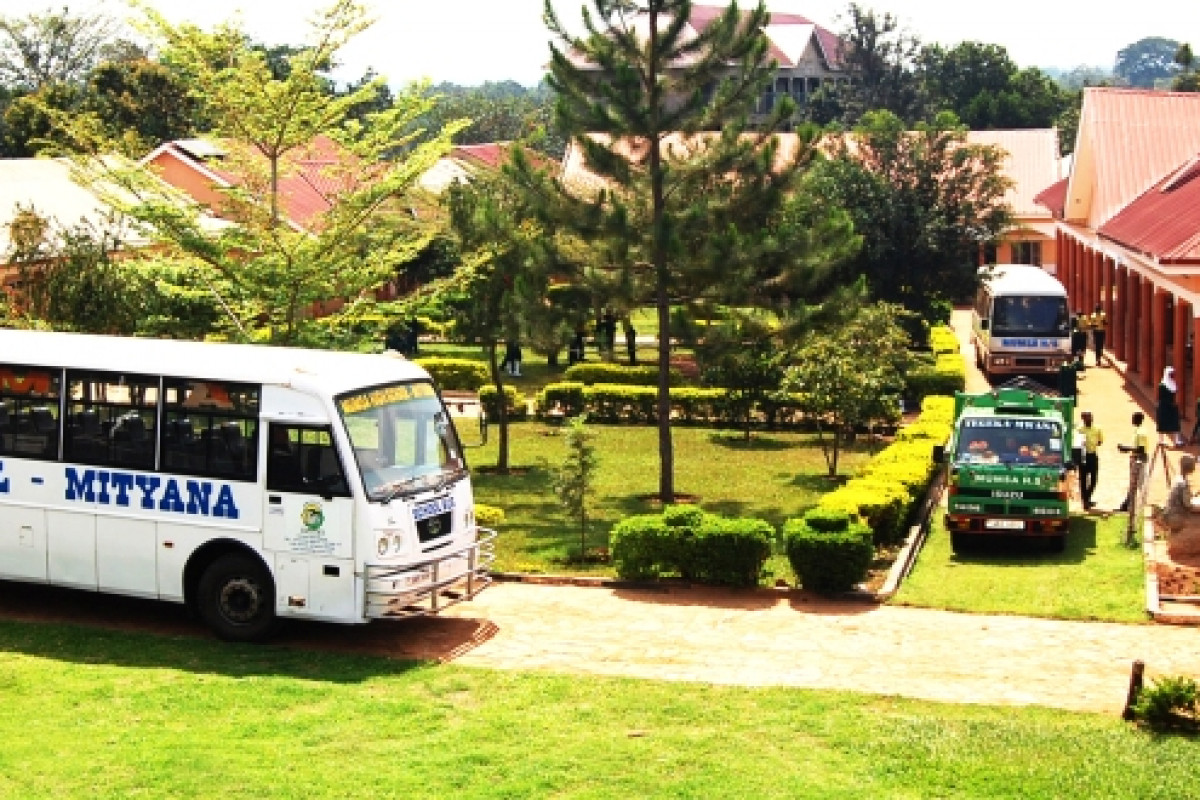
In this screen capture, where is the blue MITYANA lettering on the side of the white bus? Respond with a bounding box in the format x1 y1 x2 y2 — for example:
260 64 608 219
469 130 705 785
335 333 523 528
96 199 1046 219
63 464 241 519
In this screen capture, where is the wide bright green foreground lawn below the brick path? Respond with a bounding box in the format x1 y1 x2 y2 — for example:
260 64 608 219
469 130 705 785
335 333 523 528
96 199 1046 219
0 622 1200 800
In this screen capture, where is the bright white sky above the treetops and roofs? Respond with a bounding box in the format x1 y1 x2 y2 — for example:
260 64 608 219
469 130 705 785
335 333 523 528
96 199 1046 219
32 0 1200 86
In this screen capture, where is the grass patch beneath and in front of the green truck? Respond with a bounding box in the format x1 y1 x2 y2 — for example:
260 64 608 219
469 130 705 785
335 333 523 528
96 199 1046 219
894 515 1147 622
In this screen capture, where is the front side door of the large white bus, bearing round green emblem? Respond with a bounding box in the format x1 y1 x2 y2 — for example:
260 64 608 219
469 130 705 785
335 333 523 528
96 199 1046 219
263 422 355 616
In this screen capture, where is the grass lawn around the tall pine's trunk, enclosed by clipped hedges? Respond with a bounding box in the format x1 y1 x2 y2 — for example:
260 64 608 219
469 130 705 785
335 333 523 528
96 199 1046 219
468 422 877 582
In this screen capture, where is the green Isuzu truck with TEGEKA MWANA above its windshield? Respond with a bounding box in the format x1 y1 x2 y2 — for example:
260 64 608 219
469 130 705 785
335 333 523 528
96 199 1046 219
934 386 1079 551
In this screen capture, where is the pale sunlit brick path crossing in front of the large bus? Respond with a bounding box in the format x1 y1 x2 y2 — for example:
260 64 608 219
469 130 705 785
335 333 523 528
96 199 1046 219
407 583 1200 712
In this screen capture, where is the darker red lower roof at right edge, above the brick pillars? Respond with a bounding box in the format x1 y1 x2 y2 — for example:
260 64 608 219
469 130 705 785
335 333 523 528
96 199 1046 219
1097 151 1200 264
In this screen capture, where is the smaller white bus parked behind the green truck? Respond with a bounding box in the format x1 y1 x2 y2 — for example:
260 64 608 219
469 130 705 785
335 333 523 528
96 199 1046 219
972 264 1070 380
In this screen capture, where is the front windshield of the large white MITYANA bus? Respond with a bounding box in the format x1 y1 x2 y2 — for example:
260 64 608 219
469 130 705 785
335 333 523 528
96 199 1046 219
337 381 466 503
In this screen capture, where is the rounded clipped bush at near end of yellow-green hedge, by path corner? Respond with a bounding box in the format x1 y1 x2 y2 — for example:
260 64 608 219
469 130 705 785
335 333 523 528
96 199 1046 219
784 509 875 594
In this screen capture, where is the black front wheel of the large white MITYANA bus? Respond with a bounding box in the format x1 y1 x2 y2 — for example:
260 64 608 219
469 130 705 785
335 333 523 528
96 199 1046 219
197 553 275 642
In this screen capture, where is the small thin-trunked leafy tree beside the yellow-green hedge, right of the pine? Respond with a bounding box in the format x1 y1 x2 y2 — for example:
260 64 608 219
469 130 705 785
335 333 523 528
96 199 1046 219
782 303 912 477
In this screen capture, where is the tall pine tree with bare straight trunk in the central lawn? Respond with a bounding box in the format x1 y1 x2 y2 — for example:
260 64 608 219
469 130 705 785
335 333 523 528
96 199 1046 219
544 0 850 503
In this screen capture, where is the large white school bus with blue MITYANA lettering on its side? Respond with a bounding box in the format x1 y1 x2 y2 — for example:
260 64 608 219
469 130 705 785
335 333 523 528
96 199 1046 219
0 330 496 640
